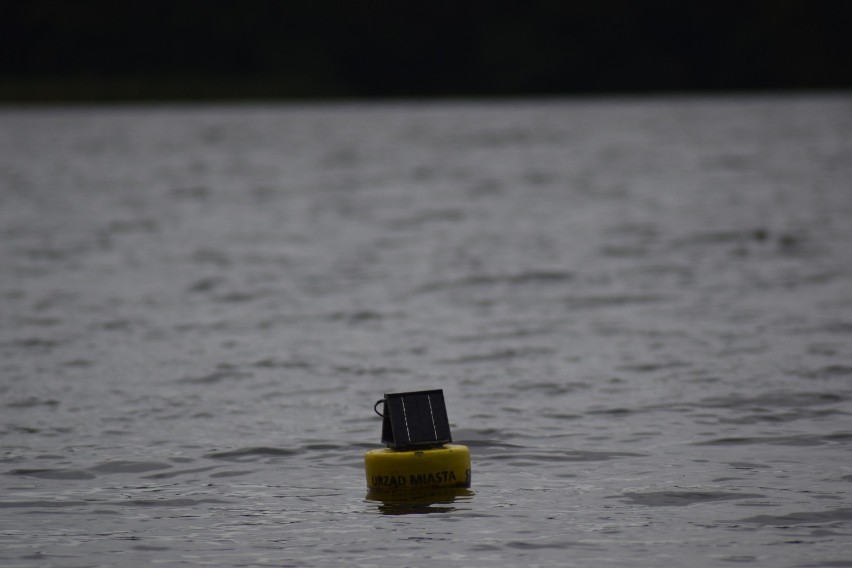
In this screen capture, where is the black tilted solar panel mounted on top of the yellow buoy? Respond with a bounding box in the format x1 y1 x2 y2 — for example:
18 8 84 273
377 389 453 450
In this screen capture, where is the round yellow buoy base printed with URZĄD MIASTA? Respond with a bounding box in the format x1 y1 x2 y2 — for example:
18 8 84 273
364 444 471 492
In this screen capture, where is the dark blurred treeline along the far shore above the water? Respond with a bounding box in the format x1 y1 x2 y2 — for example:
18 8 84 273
0 0 852 100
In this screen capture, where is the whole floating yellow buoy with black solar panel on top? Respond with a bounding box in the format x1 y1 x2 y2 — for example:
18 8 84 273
364 390 471 492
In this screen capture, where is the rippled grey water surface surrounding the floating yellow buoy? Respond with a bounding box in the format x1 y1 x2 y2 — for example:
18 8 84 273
0 94 852 567
